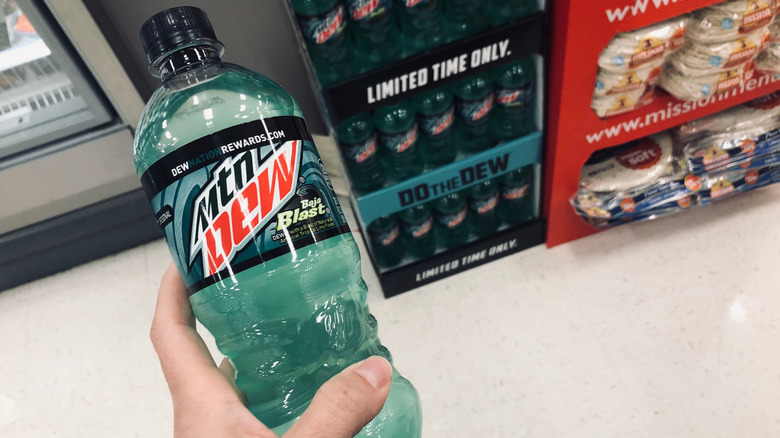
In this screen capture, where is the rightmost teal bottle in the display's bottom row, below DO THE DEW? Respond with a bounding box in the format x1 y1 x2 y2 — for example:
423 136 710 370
498 165 534 225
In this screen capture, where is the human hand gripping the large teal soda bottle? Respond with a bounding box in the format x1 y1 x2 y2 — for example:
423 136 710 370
151 264 392 438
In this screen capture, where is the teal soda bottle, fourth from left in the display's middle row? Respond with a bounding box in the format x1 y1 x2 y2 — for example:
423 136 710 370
452 72 496 154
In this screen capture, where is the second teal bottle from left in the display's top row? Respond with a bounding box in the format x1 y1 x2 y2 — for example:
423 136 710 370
344 0 403 71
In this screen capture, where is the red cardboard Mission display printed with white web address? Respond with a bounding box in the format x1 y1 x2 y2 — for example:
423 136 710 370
543 0 780 247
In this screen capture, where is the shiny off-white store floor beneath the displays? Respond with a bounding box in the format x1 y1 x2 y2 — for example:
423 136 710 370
0 182 780 438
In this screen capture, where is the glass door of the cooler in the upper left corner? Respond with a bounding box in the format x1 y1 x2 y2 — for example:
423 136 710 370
0 0 113 160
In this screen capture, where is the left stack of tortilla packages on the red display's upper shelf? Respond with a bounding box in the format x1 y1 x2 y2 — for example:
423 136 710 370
591 17 686 118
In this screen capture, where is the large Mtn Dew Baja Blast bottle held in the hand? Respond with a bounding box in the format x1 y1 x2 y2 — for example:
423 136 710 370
134 7 421 438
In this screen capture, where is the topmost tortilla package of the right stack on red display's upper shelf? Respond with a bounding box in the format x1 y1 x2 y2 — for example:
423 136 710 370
686 0 775 42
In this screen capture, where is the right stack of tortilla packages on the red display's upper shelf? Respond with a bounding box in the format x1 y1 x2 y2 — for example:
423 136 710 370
658 0 775 100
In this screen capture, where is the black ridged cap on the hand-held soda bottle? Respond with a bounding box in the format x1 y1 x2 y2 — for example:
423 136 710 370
140 6 223 64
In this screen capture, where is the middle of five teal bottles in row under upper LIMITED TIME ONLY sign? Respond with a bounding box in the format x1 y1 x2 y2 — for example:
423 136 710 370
412 88 458 168
